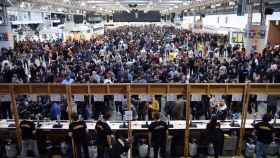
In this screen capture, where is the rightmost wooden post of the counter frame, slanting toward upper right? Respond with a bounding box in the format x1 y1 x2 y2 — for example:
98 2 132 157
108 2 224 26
236 84 250 156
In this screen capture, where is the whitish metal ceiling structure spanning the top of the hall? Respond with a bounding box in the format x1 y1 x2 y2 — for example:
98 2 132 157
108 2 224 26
7 0 280 14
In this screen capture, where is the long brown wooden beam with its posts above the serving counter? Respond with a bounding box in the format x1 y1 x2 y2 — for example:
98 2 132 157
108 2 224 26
0 83 280 157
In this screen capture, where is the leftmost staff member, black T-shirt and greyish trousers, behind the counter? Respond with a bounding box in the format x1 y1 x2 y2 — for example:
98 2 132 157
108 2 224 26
20 116 40 158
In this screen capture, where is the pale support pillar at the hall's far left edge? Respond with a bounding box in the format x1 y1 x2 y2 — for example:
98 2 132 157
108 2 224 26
0 0 14 49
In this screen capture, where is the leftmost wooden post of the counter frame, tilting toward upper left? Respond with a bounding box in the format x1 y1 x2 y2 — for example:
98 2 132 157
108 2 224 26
9 85 21 146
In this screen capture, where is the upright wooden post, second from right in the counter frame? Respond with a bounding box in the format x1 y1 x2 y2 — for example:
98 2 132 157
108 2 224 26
184 84 190 158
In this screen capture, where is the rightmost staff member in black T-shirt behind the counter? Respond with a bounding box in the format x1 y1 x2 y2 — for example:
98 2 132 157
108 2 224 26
253 114 274 158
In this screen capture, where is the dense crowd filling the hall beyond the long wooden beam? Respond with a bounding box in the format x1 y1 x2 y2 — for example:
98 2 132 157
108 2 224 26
0 25 280 84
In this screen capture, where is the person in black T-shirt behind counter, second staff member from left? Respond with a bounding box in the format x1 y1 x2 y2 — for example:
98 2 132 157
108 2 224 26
69 113 89 158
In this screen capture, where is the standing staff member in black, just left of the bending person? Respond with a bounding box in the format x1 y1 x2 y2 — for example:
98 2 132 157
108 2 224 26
95 112 112 158
